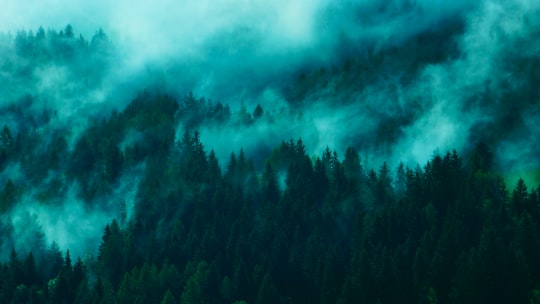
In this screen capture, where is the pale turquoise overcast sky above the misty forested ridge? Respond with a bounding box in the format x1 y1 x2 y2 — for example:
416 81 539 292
0 0 468 64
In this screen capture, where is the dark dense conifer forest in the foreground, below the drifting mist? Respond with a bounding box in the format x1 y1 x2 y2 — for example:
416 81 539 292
0 89 540 303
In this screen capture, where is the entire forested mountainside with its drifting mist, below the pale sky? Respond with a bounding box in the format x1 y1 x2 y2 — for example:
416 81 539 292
0 0 540 304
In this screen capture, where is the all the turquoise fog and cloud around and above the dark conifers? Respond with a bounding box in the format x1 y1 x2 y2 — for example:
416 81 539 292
0 0 540 254
